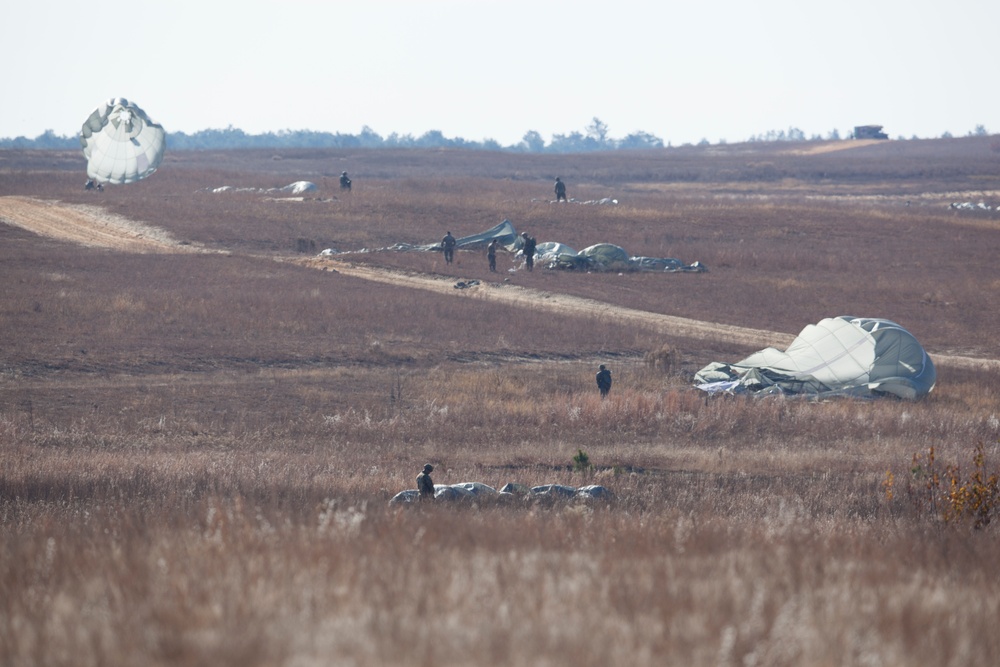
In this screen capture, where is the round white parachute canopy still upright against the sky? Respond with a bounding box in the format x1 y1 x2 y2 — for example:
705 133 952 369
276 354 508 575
80 97 167 184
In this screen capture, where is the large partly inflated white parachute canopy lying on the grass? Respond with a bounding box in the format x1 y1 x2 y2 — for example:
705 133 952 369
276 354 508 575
695 316 936 399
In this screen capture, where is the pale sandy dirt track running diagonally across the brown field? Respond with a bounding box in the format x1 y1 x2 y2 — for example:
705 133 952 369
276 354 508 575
0 197 1000 368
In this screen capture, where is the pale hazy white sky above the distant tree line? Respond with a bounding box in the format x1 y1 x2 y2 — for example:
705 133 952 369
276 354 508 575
0 0 1000 146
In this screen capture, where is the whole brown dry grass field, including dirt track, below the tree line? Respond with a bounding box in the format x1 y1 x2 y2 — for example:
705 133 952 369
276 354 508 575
0 137 1000 667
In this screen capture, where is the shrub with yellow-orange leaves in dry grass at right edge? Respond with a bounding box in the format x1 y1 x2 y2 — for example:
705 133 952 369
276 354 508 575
900 442 1000 529
